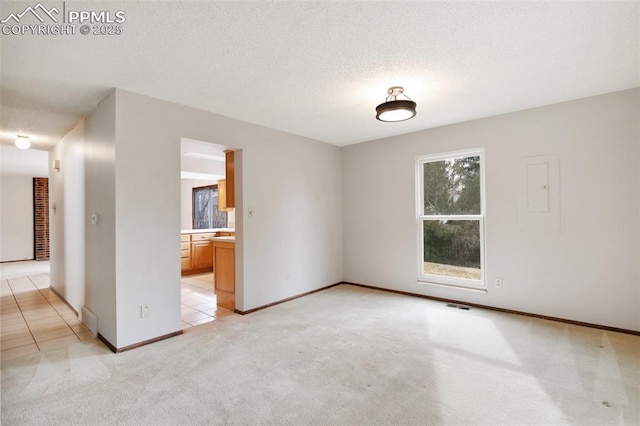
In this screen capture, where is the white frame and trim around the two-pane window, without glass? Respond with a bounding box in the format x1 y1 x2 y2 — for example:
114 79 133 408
416 148 487 292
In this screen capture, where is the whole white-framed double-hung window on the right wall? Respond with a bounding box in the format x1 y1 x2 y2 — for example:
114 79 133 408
416 150 485 288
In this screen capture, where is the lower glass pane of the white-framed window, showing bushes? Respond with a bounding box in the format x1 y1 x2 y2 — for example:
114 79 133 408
423 220 481 280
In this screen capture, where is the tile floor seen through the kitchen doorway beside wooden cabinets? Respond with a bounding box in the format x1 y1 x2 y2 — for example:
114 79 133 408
182 273 234 330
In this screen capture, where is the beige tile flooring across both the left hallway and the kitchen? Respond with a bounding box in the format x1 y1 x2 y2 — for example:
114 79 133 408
0 273 234 360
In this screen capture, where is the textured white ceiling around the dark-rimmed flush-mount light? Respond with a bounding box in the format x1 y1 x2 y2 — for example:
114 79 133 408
0 0 640 149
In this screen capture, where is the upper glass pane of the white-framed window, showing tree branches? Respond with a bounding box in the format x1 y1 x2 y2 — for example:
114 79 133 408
423 156 482 215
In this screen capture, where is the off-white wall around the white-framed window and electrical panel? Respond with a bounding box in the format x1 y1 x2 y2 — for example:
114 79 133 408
343 89 640 330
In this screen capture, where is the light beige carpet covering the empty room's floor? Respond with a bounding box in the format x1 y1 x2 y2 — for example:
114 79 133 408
2 285 640 425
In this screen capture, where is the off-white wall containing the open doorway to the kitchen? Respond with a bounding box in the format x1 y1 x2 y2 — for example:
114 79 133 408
109 90 342 347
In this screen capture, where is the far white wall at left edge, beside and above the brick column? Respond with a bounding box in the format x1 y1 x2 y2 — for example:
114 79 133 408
0 145 48 262
